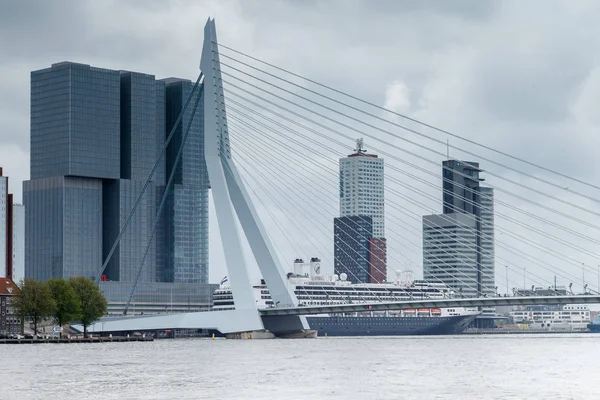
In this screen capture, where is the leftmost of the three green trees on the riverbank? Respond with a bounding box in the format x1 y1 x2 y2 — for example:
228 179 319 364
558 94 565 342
12 279 56 335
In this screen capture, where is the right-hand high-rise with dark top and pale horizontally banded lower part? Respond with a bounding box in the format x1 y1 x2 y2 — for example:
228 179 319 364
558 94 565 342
423 160 495 297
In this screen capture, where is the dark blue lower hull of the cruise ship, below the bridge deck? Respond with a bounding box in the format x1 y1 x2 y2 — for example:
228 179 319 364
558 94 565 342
306 314 477 336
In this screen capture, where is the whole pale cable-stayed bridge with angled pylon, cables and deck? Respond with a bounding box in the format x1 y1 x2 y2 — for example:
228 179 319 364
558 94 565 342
82 19 600 336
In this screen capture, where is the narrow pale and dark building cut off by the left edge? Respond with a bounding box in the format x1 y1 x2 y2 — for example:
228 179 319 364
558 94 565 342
0 167 13 279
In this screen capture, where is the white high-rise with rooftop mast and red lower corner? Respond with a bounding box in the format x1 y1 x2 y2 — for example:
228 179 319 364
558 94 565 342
334 139 387 282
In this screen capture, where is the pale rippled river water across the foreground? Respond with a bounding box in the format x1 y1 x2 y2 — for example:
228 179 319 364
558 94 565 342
0 334 600 400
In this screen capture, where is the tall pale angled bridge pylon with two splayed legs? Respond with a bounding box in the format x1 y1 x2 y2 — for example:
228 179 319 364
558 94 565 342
200 18 308 334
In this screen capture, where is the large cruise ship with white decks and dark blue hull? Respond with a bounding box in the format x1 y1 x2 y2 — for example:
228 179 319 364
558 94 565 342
213 258 479 336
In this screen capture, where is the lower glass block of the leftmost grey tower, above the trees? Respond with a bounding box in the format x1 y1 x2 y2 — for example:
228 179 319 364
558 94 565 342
23 176 102 280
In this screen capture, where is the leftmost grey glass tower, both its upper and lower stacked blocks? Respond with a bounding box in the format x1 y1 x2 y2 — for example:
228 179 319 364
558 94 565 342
23 62 121 280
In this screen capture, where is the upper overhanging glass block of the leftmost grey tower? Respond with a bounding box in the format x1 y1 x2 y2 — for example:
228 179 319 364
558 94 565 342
31 63 120 179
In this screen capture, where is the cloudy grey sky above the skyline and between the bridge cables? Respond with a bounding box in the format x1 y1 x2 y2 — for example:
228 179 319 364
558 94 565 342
0 0 600 290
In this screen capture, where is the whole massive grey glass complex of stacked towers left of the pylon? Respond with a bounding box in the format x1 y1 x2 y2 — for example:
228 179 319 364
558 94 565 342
24 62 210 311
